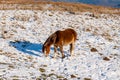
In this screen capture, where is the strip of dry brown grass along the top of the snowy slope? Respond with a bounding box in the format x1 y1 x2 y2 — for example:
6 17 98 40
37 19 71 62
0 0 120 14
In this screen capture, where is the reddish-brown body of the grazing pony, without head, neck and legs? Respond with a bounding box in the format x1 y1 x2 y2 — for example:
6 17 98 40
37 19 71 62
54 28 77 45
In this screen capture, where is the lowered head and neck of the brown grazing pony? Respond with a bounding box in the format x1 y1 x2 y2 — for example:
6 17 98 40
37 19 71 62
42 34 56 57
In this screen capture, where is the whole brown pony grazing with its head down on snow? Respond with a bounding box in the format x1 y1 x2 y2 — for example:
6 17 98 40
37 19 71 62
42 28 77 58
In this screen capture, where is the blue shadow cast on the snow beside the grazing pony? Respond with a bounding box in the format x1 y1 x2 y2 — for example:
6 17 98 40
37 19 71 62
9 41 43 56
